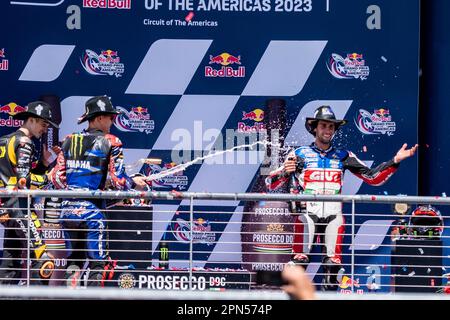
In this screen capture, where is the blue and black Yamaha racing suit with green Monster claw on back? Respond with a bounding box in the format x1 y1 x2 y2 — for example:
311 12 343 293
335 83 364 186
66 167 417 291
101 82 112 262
49 129 134 286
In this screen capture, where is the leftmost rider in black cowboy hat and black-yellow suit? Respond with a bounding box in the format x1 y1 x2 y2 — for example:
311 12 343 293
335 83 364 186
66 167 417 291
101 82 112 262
0 101 60 284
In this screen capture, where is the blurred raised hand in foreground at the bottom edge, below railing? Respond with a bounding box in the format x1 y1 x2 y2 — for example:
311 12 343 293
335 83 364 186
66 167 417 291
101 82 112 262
281 265 316 300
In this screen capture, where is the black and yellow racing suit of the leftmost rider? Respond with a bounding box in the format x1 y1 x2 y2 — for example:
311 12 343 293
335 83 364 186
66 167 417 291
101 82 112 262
0 129 54 284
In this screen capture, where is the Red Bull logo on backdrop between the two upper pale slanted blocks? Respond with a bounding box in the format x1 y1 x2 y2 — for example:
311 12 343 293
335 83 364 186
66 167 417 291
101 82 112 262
205 52 245 78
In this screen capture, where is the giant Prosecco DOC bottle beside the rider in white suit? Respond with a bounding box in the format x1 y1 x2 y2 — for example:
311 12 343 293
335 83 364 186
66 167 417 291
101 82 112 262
241 99 294 271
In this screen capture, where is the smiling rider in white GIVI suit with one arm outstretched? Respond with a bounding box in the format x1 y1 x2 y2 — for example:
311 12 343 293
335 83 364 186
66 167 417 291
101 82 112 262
266 106 418 290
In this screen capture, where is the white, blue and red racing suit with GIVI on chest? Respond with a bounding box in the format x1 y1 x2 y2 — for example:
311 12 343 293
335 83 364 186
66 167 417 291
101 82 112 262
266 143 398 288
